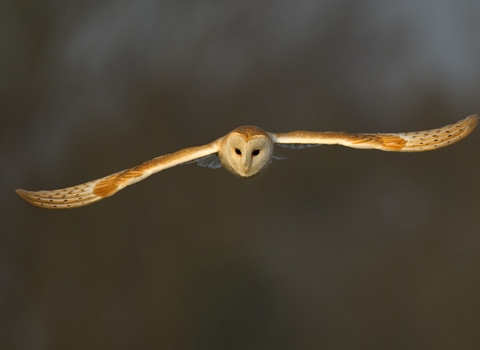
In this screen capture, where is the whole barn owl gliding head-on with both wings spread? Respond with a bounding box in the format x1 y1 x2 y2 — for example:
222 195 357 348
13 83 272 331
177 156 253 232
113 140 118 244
16 115 478 209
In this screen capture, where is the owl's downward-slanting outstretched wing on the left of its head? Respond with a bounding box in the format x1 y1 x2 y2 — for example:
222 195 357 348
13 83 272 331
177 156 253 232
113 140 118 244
16 141 218 209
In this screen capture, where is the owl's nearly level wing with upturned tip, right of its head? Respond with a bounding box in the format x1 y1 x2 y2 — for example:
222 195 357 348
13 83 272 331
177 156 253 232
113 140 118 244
270 115 478 152
